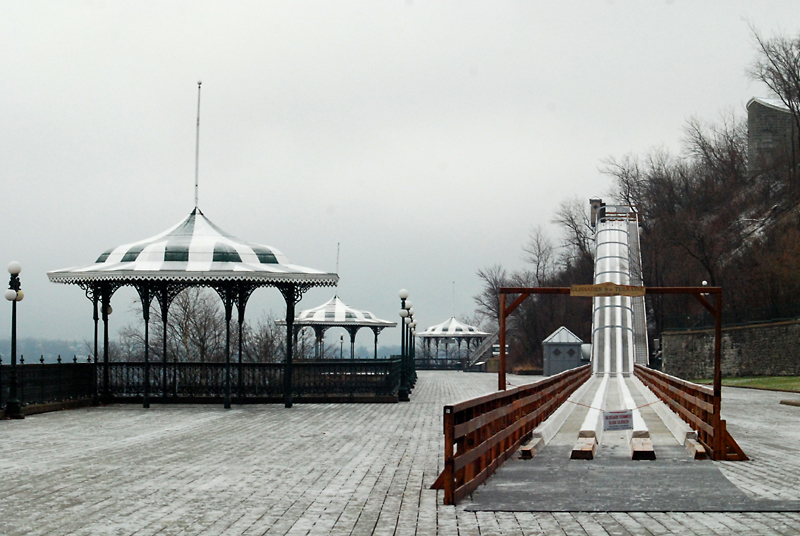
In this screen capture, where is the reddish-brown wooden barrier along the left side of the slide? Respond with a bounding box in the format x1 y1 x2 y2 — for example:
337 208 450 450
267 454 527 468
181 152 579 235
432 365 591 504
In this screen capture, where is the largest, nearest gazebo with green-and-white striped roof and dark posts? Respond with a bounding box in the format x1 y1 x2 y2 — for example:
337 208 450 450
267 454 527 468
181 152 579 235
47 207 339 408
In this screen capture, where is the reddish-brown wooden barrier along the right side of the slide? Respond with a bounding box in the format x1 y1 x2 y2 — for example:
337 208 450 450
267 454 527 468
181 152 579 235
634 365 748 461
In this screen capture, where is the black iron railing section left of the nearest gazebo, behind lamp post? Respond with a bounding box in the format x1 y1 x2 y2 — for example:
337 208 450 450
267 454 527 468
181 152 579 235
0 356 96 408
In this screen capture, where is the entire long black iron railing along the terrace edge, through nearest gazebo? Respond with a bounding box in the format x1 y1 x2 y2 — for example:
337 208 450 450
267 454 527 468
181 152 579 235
0 356 416 408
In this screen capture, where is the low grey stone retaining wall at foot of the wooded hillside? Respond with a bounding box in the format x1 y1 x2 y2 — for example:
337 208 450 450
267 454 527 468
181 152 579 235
661 320 800 380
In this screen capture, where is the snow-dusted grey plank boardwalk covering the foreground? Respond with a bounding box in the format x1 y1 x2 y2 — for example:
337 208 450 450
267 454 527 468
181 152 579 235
0 371 800 536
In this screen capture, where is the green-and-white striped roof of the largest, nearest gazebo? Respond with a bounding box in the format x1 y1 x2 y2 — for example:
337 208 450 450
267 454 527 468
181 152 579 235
47 208 339 286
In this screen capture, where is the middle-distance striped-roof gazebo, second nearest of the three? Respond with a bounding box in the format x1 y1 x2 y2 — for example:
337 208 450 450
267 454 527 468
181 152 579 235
294 295 397 359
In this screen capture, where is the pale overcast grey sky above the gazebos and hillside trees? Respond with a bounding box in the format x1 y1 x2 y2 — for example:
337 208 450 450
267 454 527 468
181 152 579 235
0 0 800 354
